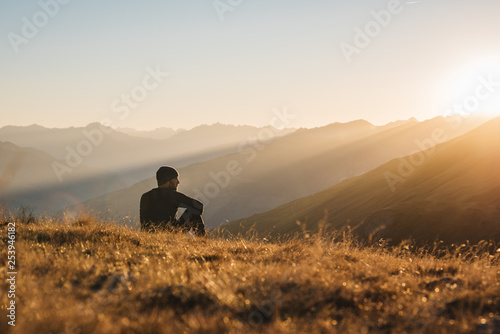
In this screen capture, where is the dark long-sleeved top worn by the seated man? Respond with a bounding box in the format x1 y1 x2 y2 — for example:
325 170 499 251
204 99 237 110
140 188 203 230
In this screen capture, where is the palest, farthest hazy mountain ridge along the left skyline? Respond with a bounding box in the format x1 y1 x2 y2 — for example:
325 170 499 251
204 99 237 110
0 123 294 186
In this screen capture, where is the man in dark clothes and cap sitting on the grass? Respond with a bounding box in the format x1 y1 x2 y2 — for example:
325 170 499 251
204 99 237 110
140 166 206 236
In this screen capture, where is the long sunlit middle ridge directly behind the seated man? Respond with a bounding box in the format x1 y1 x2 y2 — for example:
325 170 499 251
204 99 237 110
80 113 490 228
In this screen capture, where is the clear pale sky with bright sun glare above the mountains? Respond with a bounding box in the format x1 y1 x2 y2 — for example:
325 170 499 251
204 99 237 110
0 0 500 129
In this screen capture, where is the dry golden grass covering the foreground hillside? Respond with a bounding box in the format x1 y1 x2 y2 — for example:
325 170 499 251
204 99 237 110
0 210 500 333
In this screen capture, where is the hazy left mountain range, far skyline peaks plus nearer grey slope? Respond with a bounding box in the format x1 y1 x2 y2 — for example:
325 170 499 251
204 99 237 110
0 123 294 212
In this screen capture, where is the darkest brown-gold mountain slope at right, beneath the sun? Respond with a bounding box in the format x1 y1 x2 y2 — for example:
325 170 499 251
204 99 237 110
224 118 500 242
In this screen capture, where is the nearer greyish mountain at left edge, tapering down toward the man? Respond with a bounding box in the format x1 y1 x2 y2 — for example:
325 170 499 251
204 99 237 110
0 142 125 212
